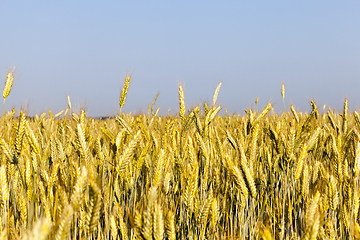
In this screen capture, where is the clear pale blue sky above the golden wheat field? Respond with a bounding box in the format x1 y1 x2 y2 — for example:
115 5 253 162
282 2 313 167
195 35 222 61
0 0 360 117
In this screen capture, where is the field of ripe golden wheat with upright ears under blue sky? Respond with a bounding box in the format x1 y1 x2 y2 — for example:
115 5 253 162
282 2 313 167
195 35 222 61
0 72 360 240
